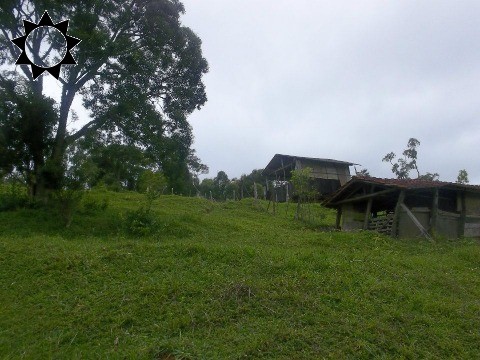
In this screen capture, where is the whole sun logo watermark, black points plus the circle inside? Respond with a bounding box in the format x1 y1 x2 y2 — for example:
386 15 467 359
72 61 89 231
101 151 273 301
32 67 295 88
10 11 82 80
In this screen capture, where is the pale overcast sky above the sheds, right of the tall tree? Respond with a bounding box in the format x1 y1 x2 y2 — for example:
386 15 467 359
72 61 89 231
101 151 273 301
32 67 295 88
182 0 480 183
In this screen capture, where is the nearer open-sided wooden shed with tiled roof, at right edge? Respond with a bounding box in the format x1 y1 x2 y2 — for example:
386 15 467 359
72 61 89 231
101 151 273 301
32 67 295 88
324 176 480 238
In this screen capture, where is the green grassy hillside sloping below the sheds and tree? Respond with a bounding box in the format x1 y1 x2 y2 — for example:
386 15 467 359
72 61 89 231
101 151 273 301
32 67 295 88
0 191 480 359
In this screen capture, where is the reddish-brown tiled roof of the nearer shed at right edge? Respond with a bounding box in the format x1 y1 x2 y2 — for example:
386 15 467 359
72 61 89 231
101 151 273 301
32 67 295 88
325 176 480 206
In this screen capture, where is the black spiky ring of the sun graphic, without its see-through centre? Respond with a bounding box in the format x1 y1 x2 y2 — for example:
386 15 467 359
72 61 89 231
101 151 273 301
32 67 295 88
11 11 82 80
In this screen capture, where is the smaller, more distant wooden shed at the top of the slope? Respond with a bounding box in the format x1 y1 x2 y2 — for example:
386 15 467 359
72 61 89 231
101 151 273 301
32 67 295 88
262 154 357 201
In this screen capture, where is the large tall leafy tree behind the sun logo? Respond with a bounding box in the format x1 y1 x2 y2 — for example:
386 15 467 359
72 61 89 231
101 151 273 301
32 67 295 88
0 0 208 195
